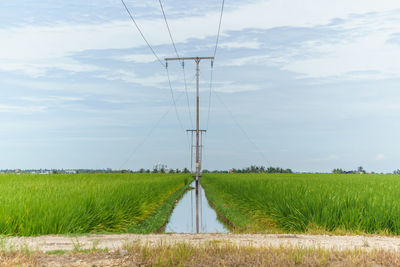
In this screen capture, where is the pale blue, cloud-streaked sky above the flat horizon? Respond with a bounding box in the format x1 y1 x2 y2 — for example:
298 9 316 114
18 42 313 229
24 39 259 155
0 0 400 172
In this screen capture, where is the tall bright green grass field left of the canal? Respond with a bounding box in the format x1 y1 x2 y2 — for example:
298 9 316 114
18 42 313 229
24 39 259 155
0 174 187 236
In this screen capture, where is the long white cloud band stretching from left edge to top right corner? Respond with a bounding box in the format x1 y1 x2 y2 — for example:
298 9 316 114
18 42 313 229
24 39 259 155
0 0 399 61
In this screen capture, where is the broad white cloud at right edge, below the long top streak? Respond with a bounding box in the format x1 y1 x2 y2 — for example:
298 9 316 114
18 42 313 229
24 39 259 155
283 12 400 80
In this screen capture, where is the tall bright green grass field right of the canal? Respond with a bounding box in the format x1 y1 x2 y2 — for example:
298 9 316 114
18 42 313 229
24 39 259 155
202 174 400 235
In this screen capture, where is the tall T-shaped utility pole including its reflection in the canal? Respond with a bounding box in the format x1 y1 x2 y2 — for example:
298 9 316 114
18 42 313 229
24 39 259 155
165 57 214 233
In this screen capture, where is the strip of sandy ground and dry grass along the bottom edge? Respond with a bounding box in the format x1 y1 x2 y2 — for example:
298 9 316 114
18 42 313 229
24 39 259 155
0 234 400 266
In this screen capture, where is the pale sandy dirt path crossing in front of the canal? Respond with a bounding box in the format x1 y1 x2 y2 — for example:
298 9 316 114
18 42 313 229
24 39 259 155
2 234 400 252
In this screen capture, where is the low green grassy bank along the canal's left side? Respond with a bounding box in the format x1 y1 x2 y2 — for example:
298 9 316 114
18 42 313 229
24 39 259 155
127 184 191 234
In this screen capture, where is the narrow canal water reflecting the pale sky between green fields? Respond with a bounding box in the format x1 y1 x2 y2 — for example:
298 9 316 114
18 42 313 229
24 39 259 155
165 182 229 233
